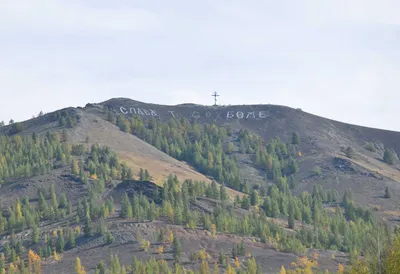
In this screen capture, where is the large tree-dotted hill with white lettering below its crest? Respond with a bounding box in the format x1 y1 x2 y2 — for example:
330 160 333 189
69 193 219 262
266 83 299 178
0 98 400 273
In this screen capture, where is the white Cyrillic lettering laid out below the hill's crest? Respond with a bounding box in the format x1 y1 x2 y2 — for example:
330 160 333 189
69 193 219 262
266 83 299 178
119 106 268 120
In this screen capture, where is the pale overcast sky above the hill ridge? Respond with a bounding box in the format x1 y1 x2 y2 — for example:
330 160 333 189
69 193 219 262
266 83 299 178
0 0 400 131
